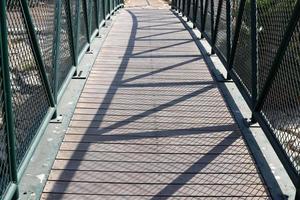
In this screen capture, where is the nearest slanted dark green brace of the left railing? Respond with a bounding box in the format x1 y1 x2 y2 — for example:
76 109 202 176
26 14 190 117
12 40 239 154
20 0 56 107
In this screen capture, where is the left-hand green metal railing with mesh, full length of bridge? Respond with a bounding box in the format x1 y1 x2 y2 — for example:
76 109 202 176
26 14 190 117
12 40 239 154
0 0 123 199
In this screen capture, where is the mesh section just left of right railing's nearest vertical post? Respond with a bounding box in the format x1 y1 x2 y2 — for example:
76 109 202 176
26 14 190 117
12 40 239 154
233 1 252 94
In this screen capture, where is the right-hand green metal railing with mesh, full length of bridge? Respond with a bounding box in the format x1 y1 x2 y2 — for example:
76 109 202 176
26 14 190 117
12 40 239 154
172 0 300 198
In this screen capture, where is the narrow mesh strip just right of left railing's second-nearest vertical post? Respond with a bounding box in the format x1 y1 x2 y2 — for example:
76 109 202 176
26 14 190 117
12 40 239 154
58 0 72 89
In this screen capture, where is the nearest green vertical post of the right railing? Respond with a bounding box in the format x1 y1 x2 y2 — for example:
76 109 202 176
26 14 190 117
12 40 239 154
251 0 258 123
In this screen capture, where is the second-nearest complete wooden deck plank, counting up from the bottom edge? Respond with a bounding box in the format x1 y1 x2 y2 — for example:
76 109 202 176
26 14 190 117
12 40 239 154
49 170 261 185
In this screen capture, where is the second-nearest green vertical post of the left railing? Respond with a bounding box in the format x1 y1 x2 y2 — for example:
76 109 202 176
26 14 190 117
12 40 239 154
52 0 62 119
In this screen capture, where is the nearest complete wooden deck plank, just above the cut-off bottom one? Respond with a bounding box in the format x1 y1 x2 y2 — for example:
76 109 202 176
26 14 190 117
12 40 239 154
44 181 267 197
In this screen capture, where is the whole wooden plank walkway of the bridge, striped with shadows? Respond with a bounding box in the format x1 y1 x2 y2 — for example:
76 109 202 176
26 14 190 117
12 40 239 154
42 0 270 200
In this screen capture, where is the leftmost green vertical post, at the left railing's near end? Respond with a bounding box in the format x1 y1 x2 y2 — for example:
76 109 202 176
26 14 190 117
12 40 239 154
0 0 19 199
